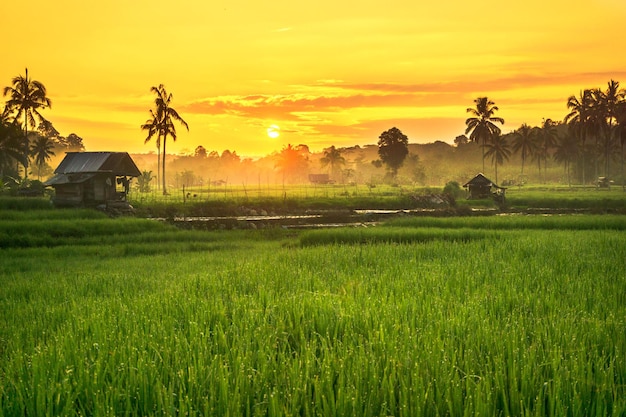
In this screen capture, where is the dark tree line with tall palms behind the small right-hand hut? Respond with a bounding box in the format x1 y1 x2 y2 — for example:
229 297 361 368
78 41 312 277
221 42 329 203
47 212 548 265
455 80 626 187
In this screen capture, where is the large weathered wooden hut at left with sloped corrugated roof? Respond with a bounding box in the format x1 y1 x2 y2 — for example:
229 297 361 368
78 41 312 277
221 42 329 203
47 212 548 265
44 152 141 207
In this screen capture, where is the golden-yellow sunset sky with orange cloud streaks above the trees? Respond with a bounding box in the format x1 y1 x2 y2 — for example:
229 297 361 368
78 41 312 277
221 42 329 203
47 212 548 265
0 0 626 157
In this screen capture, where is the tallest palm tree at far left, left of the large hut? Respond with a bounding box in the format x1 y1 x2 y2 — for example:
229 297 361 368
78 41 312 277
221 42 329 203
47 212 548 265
3 68 52 178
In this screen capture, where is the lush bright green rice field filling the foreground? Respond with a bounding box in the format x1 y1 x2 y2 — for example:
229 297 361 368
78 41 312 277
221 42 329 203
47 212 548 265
0 206 626 416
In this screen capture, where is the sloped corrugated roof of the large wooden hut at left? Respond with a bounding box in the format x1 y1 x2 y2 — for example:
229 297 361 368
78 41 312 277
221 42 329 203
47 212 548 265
54 152 141 177
